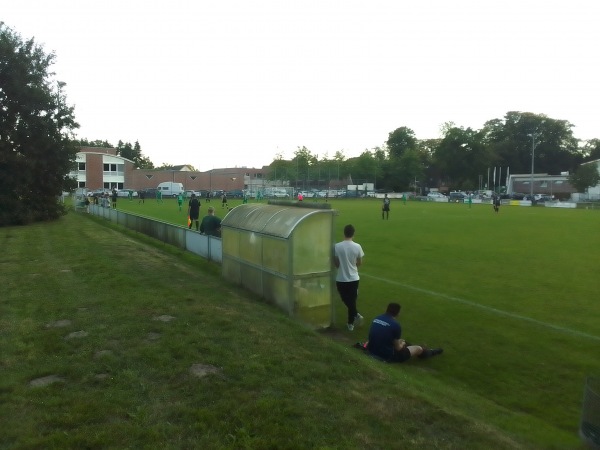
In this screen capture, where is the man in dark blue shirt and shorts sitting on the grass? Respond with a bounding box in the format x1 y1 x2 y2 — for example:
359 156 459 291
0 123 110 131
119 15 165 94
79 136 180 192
367 303 443 362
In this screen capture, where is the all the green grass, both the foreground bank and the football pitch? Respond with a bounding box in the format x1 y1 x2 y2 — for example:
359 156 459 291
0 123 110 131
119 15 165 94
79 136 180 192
0 199 600 448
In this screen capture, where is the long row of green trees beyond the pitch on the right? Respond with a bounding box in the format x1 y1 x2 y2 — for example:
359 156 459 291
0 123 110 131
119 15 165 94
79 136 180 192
269 111 600 192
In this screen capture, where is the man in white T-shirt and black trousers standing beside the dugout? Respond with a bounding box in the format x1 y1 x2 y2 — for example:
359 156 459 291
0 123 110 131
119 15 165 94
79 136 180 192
334 225 365 331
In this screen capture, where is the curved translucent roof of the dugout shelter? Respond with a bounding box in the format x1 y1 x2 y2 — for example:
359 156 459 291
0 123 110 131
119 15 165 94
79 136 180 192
221 202 333 239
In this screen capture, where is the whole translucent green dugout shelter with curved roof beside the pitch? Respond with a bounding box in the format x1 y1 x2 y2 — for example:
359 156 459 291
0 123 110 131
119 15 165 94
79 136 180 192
221 201 335 327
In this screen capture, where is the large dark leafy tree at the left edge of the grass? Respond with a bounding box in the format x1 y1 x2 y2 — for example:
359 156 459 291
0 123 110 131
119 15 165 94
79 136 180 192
0 22 78 225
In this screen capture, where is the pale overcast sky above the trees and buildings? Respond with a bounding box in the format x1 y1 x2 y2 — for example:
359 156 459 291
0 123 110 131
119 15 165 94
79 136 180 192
0 0 600 170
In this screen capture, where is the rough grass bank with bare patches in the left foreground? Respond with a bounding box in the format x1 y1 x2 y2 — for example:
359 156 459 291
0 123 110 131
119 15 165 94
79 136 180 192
0 214 522 449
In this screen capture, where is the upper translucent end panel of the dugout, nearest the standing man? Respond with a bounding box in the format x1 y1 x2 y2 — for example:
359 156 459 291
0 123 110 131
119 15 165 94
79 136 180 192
292 214 333 275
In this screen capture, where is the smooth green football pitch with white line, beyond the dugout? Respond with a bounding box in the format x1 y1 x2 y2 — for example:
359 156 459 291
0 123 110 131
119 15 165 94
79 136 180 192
113 199 600 442
